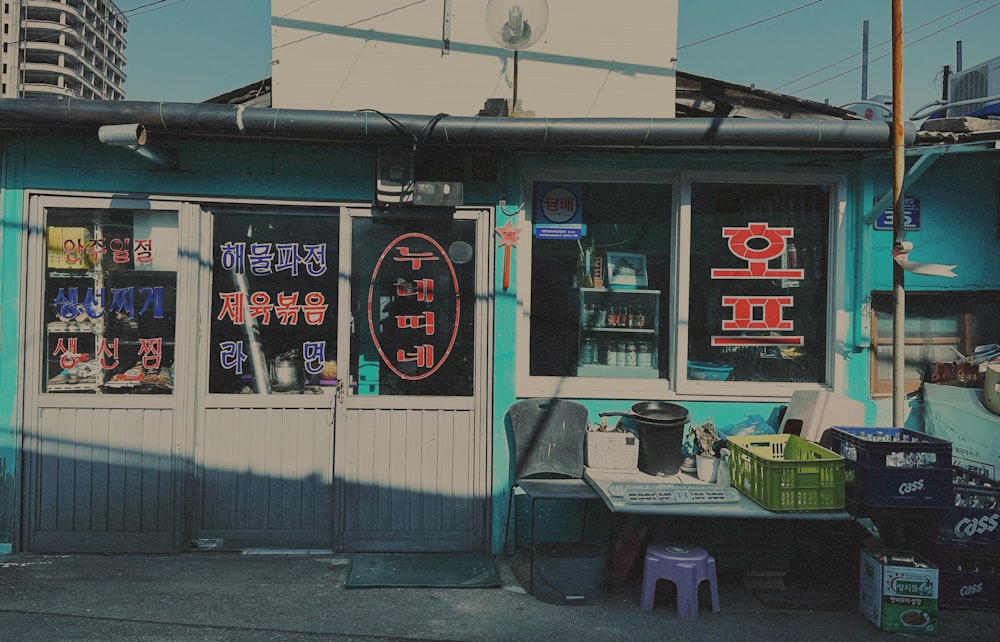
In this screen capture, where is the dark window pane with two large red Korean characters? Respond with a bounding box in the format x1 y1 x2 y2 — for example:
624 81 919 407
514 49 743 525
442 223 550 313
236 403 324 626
687 182 831 383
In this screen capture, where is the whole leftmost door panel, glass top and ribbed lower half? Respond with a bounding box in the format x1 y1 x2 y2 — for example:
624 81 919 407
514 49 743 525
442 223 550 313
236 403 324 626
22 196 183 553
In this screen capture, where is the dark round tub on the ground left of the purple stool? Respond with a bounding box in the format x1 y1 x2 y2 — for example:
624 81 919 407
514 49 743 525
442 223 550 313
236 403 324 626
532 542 608 604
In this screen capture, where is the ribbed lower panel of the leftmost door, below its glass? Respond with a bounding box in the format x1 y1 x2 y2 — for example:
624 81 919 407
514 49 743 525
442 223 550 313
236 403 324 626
25 408 175 553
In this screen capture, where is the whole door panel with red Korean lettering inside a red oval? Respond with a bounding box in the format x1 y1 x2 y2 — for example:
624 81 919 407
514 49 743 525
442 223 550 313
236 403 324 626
335 210 492 551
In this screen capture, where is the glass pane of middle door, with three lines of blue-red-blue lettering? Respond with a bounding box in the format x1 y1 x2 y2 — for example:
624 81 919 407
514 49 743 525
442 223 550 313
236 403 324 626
209 210 339 394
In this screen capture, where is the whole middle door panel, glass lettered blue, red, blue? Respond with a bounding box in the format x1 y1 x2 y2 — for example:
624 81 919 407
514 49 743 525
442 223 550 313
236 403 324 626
193 204 341 549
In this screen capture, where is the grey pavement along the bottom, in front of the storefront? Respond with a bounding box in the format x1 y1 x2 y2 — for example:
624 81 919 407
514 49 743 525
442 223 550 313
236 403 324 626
0 552 1000 642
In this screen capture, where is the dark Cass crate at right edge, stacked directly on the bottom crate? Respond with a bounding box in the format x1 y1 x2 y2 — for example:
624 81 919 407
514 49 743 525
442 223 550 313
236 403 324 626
937 466 1000 547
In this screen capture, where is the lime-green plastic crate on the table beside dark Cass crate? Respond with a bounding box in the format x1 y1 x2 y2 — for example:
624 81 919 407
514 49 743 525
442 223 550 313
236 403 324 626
727 435 844 511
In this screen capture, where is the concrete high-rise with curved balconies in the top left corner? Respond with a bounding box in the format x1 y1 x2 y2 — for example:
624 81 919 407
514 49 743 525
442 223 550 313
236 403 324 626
0 0 128 100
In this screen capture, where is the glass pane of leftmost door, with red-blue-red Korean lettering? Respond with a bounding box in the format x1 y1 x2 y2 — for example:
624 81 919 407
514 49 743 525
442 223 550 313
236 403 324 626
43 209 177 394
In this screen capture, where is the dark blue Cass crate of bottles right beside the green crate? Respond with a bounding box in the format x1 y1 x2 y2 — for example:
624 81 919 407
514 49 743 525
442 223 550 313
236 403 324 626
829 426 954 508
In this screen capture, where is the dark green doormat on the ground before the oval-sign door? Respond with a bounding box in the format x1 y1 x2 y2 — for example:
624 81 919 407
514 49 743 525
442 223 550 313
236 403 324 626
344 553 501 588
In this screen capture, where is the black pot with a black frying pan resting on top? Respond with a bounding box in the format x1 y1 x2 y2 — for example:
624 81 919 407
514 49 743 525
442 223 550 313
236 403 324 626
598 401 691 477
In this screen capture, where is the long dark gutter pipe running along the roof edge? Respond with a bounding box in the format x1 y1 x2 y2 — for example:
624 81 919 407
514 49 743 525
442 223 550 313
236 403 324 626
0 98 916 150
